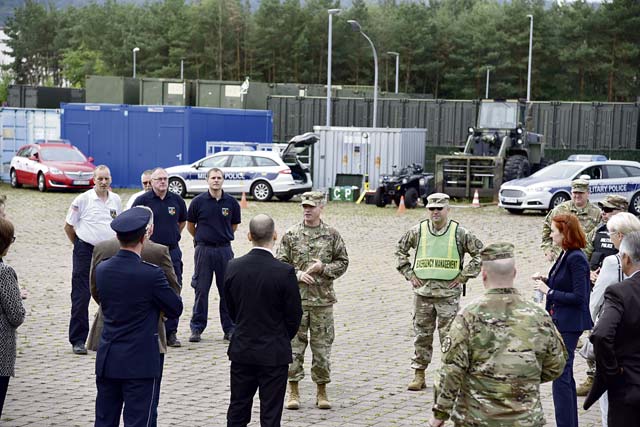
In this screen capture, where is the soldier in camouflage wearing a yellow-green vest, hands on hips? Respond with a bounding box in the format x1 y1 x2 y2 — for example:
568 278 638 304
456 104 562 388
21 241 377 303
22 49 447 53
396 193 482 391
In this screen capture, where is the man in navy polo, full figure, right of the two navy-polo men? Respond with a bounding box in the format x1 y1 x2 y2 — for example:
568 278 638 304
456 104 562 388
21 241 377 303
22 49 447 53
187 168 241 342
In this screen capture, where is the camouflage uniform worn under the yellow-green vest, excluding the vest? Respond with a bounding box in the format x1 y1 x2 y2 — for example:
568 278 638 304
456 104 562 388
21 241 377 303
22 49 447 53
396 220 482 369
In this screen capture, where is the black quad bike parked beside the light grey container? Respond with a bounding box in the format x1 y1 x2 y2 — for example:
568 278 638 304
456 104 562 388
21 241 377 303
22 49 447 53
373 163 433 209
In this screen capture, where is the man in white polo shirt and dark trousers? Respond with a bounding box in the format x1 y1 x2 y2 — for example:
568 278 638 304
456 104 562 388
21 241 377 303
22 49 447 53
64 165 122 354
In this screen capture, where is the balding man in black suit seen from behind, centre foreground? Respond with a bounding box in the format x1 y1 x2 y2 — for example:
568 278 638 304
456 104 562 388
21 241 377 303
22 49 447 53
223 214 302 427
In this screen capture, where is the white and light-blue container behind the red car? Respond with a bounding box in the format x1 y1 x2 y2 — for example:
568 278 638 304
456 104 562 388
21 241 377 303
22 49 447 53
0 108 60 181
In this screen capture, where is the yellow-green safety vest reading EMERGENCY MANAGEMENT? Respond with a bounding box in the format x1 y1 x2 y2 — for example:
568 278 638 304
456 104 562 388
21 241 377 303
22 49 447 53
413 219 462 280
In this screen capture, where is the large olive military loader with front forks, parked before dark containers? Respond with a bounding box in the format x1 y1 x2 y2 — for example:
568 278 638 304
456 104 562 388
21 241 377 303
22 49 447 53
435 100 546 201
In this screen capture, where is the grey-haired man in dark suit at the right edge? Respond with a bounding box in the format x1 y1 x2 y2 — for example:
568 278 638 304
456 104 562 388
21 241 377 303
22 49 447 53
584 232 640 427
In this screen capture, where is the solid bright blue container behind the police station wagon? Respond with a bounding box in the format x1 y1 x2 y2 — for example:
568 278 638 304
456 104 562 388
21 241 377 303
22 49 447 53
61 104 273 187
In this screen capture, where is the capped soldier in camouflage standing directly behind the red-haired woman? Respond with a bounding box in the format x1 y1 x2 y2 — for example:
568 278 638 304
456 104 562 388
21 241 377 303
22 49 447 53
540 178 602 261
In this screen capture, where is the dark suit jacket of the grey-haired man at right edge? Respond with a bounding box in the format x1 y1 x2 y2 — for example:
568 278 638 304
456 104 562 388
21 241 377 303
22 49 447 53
584 273 640 409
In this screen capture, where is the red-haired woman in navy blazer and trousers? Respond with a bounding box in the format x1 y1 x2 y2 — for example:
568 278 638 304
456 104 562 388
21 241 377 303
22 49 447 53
535 214 593 427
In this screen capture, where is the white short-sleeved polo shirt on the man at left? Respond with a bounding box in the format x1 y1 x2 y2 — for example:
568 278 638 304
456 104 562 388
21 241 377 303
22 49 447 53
66 189 122 246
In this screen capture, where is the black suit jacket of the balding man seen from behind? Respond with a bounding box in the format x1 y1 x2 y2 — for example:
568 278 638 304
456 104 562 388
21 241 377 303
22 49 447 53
224 248 302 366
